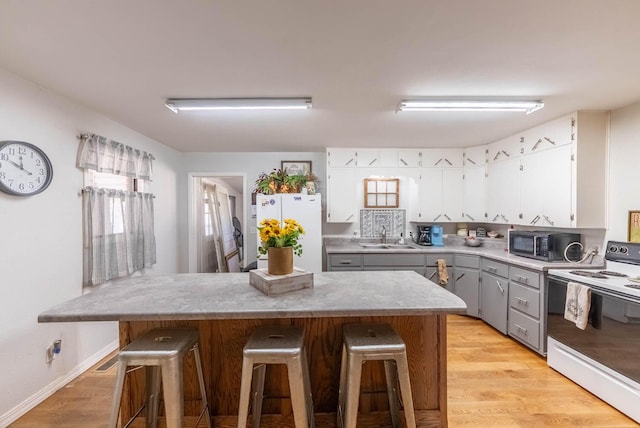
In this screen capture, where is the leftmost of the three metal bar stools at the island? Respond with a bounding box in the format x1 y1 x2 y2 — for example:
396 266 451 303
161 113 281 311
109 327 211 428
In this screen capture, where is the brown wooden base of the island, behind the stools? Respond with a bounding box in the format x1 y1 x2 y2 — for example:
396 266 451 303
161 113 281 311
120 314 447 428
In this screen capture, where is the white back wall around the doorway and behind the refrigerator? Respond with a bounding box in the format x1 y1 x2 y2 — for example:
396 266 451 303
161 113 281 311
178 152 326 272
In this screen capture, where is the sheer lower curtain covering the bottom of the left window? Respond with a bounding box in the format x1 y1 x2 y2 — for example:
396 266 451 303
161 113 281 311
83 187 156 285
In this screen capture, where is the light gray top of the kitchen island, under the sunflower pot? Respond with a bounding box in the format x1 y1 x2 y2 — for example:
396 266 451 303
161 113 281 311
38 271 466 322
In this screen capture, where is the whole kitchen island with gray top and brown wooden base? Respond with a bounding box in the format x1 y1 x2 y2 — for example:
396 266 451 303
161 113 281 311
38 271 466 427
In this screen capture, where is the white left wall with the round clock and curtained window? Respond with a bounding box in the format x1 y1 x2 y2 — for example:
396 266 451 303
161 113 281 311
0 70 180 426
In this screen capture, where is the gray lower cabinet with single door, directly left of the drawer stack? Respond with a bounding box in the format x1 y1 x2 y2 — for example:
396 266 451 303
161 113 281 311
480 259 509 334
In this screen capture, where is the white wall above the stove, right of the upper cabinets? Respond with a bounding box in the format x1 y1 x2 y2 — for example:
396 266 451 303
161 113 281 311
606 102 640 241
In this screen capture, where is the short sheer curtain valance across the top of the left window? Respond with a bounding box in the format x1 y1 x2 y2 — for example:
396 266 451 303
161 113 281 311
77 134 155 180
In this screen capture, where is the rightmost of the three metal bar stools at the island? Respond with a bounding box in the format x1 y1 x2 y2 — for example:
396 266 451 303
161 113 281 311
338 324 416 428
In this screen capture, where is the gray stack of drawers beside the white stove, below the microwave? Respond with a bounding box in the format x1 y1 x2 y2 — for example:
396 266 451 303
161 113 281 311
509 266 546 354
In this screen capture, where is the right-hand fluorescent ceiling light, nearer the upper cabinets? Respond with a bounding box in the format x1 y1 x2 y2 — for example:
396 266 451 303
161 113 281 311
398 100 544 114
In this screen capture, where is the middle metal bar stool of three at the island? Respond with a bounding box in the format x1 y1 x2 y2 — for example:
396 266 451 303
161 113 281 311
238 326 315 428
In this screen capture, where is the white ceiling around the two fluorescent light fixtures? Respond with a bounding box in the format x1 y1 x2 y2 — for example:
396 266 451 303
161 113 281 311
0 0 640 152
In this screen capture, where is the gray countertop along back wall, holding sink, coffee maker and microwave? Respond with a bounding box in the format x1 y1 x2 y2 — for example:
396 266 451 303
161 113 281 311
324 238 604 272
